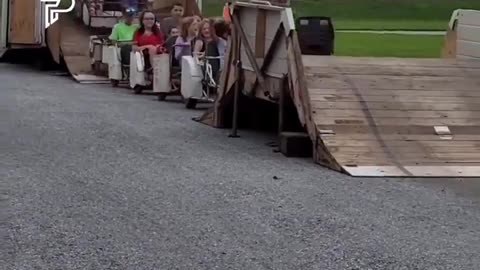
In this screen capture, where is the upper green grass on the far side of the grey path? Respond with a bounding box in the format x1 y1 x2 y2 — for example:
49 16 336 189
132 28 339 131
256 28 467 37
204 0 480 30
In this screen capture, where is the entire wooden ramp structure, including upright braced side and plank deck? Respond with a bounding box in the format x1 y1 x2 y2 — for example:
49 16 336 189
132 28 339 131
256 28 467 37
198 2 480 177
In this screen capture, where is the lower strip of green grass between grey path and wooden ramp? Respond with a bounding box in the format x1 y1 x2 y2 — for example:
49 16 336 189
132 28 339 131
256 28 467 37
335 33 443 58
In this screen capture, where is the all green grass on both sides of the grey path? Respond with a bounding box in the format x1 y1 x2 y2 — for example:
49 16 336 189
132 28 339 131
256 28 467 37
204 0 458 57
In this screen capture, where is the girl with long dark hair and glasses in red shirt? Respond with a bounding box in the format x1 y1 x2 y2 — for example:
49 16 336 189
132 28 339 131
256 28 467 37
132 11 165 69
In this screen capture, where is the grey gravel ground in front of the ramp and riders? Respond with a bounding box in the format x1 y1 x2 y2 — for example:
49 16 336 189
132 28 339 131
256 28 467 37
0 64 480 270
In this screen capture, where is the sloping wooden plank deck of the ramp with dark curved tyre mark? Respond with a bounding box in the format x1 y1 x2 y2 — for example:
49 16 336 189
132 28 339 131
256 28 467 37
296 55 480 177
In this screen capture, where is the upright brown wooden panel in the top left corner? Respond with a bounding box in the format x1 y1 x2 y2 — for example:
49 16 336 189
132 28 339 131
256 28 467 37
8 0 37 44
